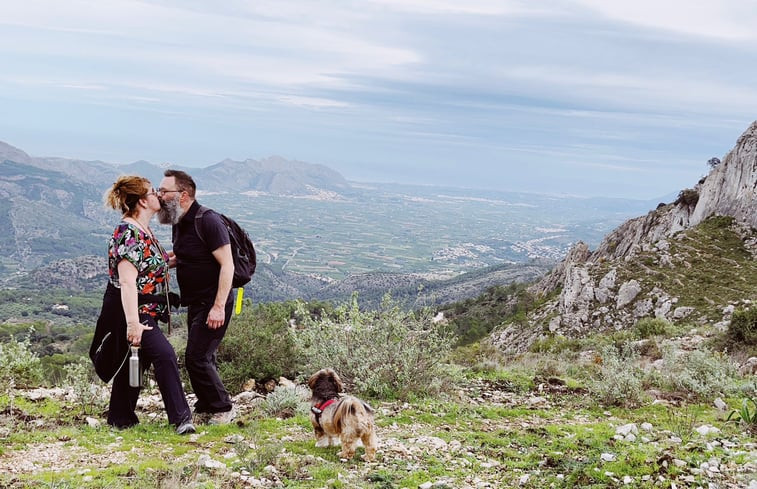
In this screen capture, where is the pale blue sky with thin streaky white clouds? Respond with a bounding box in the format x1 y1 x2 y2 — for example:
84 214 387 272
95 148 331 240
0 0 757 200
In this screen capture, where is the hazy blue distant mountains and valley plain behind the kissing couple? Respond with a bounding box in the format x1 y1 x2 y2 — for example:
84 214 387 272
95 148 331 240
0 137 708 312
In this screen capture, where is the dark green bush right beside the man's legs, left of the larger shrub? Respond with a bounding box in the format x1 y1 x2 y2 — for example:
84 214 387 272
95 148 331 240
218 302 298 393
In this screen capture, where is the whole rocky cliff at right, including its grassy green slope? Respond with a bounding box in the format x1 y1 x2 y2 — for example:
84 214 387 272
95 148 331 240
491 121 757 353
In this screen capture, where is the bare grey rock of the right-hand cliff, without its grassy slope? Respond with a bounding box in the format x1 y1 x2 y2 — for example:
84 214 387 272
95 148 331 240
490 121 757 353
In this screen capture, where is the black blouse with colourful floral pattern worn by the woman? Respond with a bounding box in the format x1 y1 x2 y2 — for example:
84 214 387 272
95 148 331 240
108 221 168 317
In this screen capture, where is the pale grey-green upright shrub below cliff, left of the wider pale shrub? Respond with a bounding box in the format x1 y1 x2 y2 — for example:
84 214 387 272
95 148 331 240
589 344 644 406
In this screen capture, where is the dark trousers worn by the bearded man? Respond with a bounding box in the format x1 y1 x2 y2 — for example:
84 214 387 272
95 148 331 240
184 294 234 413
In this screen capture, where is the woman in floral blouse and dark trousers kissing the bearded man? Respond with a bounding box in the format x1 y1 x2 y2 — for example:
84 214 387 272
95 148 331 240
98 175 195 435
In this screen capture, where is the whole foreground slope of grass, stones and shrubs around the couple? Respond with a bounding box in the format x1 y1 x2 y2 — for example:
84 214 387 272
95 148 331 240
0 288 757 489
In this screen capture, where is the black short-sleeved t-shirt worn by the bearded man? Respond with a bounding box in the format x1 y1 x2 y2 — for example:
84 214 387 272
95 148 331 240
173 201 231 306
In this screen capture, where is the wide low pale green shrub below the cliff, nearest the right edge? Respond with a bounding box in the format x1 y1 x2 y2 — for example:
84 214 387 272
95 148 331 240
661 347 738 399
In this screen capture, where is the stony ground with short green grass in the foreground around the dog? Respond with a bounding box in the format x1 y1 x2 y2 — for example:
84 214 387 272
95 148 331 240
0 378 757 489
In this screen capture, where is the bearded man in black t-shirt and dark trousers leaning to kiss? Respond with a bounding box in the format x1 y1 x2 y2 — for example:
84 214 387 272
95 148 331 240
158 170 235 424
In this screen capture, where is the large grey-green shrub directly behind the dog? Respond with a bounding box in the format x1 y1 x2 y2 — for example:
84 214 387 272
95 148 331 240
295 295 454 398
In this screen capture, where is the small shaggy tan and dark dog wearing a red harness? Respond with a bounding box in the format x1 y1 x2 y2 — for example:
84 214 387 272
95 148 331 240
308 368 377 462
